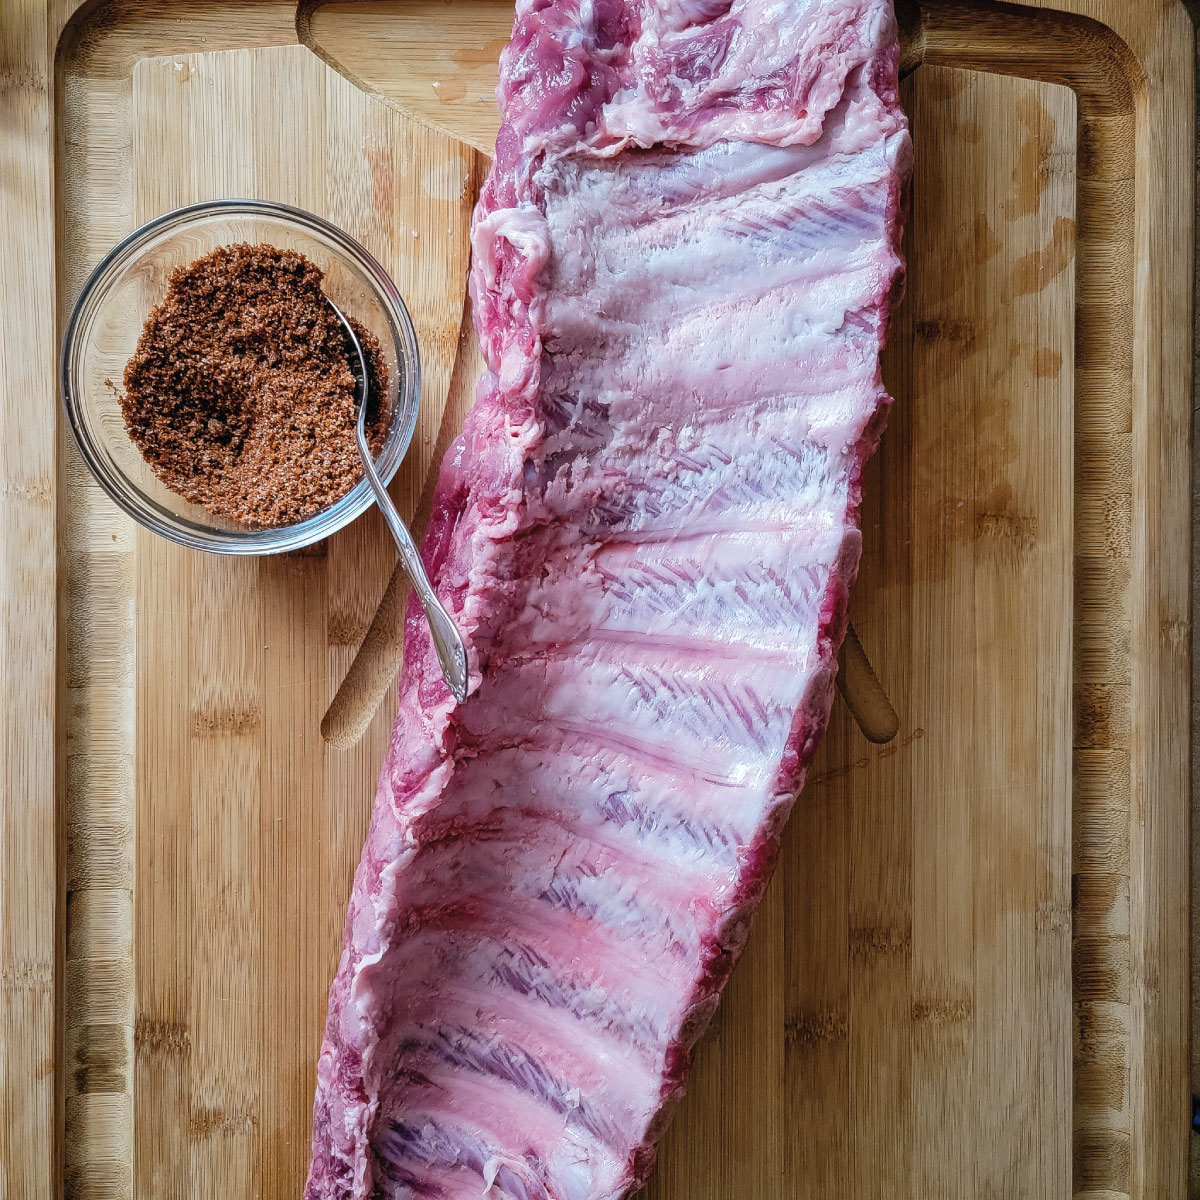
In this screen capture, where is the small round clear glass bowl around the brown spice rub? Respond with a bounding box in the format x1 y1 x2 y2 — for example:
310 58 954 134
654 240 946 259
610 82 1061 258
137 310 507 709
60 199 421 554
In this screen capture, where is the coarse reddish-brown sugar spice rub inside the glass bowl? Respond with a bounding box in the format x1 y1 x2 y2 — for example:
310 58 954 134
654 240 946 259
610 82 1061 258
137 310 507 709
121 244 388 528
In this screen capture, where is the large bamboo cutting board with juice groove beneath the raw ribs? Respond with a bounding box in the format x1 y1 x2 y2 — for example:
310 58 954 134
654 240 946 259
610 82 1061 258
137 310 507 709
0 0 1194 1200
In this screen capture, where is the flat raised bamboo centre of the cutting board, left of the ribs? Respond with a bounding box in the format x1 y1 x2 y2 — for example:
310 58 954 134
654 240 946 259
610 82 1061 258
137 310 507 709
132 46 475 1196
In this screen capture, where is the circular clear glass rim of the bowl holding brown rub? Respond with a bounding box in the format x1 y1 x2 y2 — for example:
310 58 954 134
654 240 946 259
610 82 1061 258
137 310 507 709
59 198 421 554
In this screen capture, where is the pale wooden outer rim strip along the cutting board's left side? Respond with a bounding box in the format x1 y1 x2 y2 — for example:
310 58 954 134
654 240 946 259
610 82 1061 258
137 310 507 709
0 0 61 1195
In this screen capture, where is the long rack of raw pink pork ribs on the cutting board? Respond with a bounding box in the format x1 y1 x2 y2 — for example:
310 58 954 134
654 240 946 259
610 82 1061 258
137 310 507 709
306 0 910 1200
